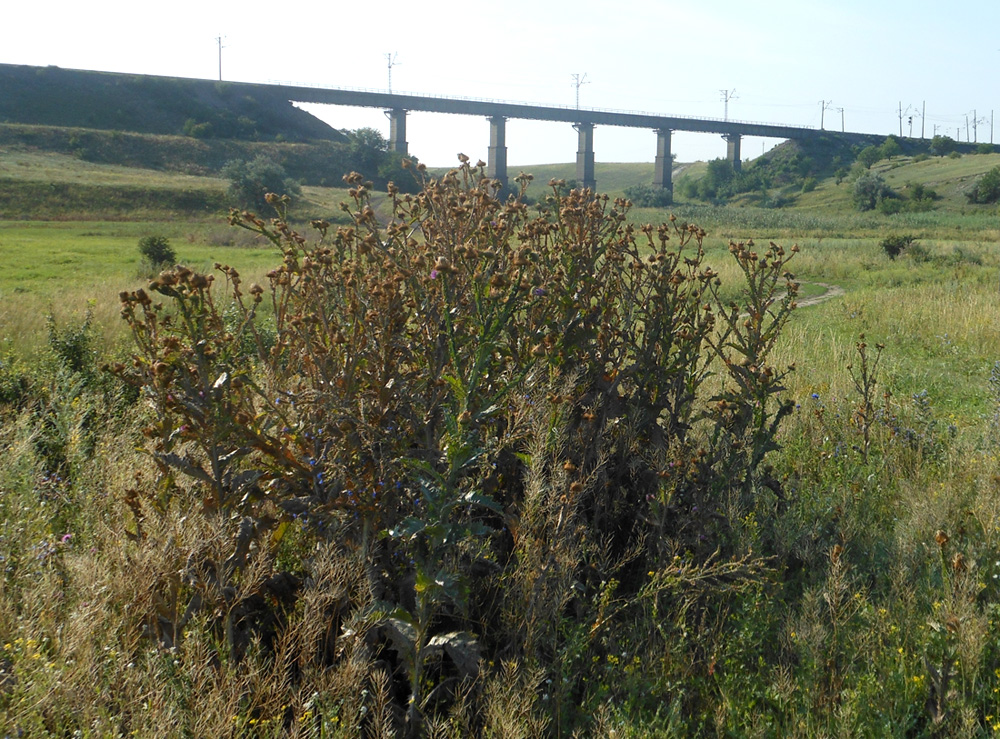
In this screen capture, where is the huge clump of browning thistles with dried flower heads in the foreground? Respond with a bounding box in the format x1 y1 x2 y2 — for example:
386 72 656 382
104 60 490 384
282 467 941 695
114 163 798 735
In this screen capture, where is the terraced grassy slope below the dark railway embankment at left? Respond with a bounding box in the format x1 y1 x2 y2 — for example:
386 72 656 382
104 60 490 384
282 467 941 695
0 124 412 220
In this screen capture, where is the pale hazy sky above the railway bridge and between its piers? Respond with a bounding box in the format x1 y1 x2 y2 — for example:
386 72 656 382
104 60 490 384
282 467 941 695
0 0 1000 169
